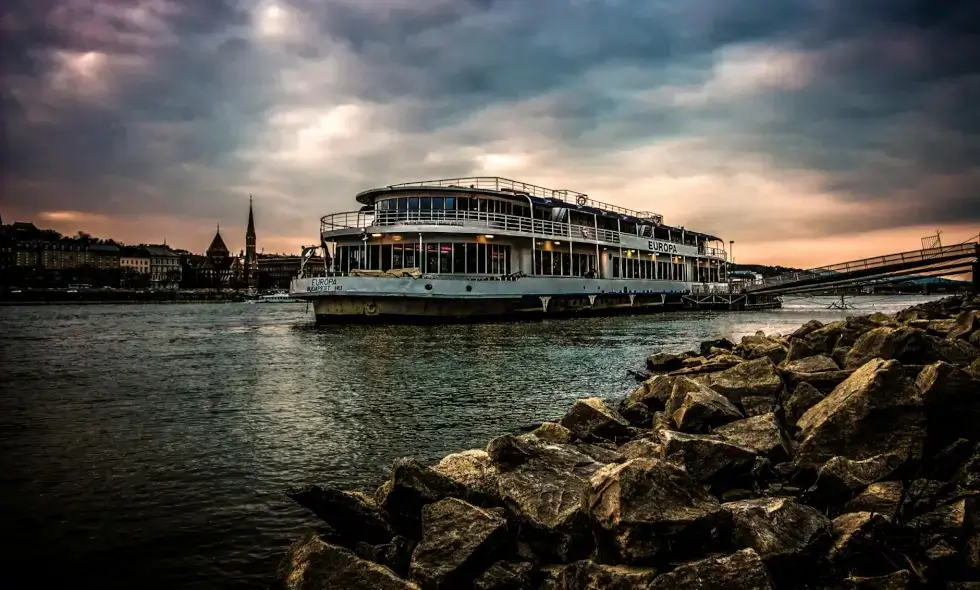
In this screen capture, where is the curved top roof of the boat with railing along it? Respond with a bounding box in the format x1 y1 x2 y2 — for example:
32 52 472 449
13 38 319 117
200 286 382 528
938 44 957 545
355 176 722 242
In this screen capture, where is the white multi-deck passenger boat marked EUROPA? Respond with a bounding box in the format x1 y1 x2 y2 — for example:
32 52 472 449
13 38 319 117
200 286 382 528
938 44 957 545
290 177 760 323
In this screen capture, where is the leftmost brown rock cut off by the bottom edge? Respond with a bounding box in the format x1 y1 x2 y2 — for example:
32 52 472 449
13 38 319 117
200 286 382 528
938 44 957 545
277 532 419 590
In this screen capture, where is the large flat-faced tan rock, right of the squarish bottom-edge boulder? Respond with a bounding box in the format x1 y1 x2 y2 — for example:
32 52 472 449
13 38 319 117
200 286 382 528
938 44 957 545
487 436 602 562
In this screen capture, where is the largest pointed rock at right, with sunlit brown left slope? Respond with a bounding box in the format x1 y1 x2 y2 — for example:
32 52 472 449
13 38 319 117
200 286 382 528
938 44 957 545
797 359 925 464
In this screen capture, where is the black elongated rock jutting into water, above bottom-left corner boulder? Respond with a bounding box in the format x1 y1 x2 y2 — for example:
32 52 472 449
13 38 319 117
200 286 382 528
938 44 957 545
286 485 395 544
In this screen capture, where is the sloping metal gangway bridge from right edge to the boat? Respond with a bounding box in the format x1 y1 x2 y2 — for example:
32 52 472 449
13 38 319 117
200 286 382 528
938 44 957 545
743 235 980 295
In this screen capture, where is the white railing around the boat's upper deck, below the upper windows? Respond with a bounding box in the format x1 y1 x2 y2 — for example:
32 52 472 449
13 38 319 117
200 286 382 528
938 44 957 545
320 209 726 260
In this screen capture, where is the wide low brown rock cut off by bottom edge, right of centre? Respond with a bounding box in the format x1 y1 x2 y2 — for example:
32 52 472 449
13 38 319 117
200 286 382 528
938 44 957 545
649 549 772 590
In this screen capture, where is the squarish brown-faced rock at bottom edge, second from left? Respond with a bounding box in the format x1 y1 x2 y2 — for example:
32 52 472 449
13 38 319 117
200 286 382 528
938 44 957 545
409 498 507 589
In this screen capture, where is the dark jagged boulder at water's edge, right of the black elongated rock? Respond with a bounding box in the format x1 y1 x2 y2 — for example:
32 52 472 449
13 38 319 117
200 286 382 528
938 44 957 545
380 458 466 540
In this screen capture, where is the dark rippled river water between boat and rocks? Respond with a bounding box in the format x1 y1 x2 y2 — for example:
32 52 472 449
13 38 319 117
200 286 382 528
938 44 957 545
0 297 940 588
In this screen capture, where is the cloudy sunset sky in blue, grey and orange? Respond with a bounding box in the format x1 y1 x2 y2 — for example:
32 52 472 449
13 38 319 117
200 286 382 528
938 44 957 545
0 0 980 266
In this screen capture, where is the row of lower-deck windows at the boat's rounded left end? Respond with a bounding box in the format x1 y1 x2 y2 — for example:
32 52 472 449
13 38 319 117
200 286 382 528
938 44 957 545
334 243 511 275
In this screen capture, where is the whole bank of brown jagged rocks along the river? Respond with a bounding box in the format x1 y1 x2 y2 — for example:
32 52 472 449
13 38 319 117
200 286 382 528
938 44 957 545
275 297 980 590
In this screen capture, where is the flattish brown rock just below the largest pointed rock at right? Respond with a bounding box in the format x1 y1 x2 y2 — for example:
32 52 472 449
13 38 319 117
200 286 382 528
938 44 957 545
806 453 907 506
